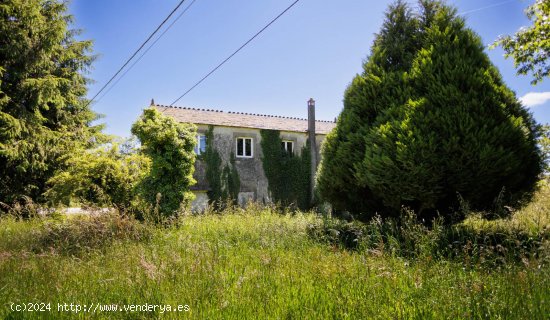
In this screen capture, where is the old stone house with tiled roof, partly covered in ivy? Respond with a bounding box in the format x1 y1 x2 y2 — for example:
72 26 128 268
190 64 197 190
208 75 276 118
151 99 336 211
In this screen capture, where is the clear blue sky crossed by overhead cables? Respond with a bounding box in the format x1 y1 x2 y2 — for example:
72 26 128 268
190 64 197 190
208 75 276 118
69 0 550 136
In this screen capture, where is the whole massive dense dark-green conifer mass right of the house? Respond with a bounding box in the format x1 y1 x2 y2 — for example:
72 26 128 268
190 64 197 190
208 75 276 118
319 1 541 222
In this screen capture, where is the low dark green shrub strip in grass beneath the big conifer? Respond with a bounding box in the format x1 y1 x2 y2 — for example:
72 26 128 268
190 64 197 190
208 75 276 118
307 210 550 269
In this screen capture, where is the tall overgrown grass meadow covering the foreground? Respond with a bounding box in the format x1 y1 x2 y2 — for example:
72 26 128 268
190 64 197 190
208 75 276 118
0 194 550 319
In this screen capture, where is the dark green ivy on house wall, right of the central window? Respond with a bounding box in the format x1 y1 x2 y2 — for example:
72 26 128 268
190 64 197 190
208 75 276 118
260 130 311 210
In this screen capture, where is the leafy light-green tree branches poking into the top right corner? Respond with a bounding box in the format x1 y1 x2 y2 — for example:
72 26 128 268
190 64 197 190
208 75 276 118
493 0 550 84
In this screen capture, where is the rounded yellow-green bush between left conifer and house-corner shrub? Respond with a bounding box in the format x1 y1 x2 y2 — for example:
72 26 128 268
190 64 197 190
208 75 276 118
45 143 150 211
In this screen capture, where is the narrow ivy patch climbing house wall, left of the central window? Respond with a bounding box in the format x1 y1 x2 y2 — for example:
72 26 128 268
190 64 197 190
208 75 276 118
203 126 241 210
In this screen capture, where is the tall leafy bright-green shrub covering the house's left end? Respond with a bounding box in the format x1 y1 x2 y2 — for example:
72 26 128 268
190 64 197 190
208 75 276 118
132 108 196 219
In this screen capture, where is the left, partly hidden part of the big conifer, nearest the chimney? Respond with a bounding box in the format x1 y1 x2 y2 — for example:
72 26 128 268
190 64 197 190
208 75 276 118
317 1 421 215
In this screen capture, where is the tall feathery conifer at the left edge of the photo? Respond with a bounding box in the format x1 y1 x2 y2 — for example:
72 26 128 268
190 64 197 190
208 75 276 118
0 0 102 202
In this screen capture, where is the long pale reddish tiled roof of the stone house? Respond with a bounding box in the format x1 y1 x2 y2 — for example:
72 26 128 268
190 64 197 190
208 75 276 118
154 104 336 134
